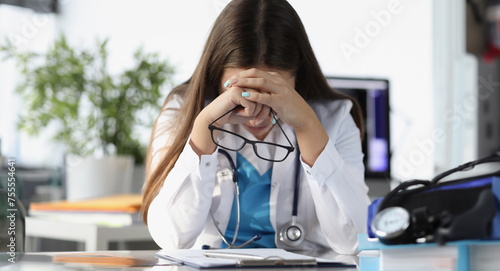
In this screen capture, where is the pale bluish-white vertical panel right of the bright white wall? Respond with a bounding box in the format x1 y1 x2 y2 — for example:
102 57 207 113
432 0 478 178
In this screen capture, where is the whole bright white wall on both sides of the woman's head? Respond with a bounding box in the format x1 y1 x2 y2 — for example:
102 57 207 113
0 0 433 183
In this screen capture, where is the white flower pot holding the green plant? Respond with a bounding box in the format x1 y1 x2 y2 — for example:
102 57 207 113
65 155 134 201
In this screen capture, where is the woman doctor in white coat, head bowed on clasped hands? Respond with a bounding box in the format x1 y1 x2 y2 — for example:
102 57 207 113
143 0 369 254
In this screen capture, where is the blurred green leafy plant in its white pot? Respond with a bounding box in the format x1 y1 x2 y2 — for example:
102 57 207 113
0 36 174 202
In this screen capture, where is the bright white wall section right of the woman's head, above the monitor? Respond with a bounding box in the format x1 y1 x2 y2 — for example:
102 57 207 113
290 0 433 180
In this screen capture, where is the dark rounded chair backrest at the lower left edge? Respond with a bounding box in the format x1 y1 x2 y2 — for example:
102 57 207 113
0 189 26 252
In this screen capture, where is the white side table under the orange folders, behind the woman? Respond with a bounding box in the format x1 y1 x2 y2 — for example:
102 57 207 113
26 217 152 251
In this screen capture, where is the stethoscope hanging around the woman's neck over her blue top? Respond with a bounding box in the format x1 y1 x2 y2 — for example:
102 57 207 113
210 149 305 248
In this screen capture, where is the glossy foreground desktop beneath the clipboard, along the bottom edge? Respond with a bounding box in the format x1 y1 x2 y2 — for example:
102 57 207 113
0 250 357 271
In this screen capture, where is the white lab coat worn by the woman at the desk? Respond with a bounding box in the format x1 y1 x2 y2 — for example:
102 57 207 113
148 97 369 254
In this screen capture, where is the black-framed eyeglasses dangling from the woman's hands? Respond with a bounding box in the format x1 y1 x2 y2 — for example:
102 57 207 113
208 105 295 162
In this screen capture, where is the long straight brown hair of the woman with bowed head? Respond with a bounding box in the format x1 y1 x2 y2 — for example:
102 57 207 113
142 0 363 223
